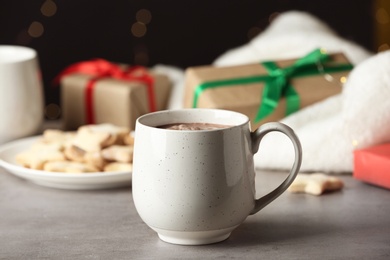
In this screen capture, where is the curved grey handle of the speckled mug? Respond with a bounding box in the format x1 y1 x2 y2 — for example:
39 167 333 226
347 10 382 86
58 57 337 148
250 122 302 215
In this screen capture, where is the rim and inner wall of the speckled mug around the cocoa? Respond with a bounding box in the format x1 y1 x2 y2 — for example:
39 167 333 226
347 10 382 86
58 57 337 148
136 108 249 133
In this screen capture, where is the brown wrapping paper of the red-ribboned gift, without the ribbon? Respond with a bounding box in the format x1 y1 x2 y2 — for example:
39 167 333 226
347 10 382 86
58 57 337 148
61 73 172 130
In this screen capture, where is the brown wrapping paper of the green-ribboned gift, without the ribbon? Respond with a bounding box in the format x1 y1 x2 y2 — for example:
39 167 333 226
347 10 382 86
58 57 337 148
184 53 349 129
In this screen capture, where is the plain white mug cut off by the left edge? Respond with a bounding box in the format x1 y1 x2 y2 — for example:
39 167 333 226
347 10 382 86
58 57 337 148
0 45 44 144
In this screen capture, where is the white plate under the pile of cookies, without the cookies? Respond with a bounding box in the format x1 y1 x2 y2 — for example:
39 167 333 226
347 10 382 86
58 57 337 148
0 136 132 190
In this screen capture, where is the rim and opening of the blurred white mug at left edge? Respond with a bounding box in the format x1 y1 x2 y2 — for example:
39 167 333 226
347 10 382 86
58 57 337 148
0 44 37 64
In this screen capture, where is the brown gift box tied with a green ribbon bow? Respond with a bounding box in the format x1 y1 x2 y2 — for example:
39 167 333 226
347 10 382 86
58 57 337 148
184 49 353 128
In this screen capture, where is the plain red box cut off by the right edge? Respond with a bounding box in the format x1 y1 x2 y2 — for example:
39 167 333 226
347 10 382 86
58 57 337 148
353 143 390 189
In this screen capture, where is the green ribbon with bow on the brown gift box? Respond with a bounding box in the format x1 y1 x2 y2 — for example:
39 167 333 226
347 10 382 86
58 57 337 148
192 49 353 122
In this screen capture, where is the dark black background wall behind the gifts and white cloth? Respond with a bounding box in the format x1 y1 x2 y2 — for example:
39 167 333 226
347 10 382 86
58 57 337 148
0 0 377 118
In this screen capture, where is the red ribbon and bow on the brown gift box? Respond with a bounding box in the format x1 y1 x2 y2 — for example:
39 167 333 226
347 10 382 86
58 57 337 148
54 59 156 124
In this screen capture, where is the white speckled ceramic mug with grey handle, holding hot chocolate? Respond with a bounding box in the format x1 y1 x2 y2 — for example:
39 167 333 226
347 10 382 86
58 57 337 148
132 109 302 245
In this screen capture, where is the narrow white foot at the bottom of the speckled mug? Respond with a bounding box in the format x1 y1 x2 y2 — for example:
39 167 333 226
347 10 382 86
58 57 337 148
151 225 238 245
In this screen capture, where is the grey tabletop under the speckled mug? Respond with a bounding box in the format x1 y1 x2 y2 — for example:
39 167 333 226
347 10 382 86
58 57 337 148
0 162 390 259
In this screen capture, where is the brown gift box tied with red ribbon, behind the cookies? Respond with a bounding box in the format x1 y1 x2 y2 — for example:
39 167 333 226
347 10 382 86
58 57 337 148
56 59 172 130
